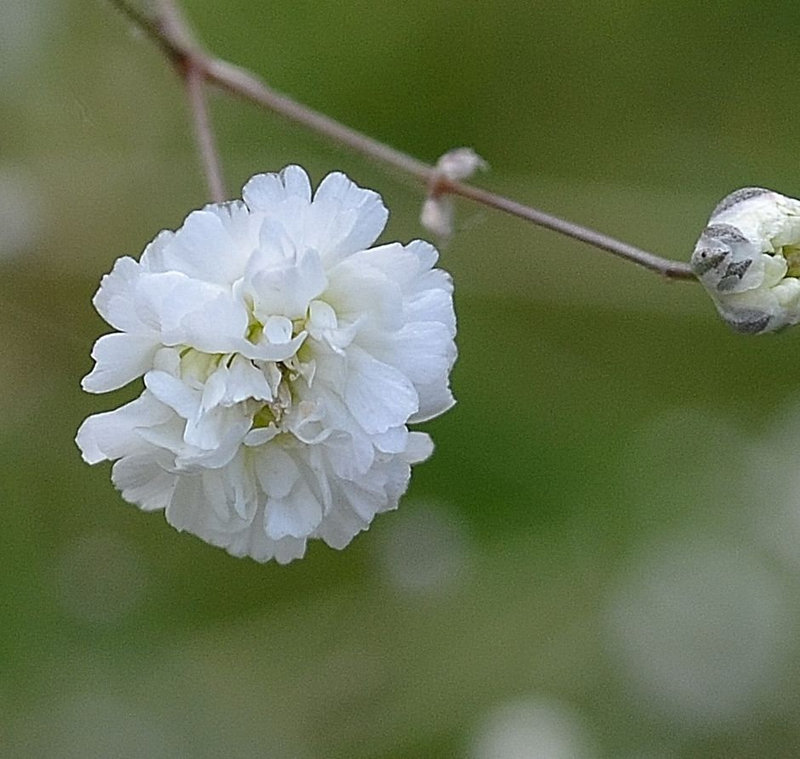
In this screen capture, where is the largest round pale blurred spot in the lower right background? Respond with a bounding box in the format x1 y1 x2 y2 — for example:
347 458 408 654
607 536 795 731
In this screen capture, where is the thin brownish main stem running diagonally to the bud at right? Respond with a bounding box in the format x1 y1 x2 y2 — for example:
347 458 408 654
111 0 696 281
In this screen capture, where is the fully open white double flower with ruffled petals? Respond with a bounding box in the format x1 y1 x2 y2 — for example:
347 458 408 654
77 166 456 563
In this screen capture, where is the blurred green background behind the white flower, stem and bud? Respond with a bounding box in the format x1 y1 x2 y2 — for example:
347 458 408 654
0 0 800 759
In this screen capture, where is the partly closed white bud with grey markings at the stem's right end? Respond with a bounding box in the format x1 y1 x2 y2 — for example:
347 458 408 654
691 187 800 334
